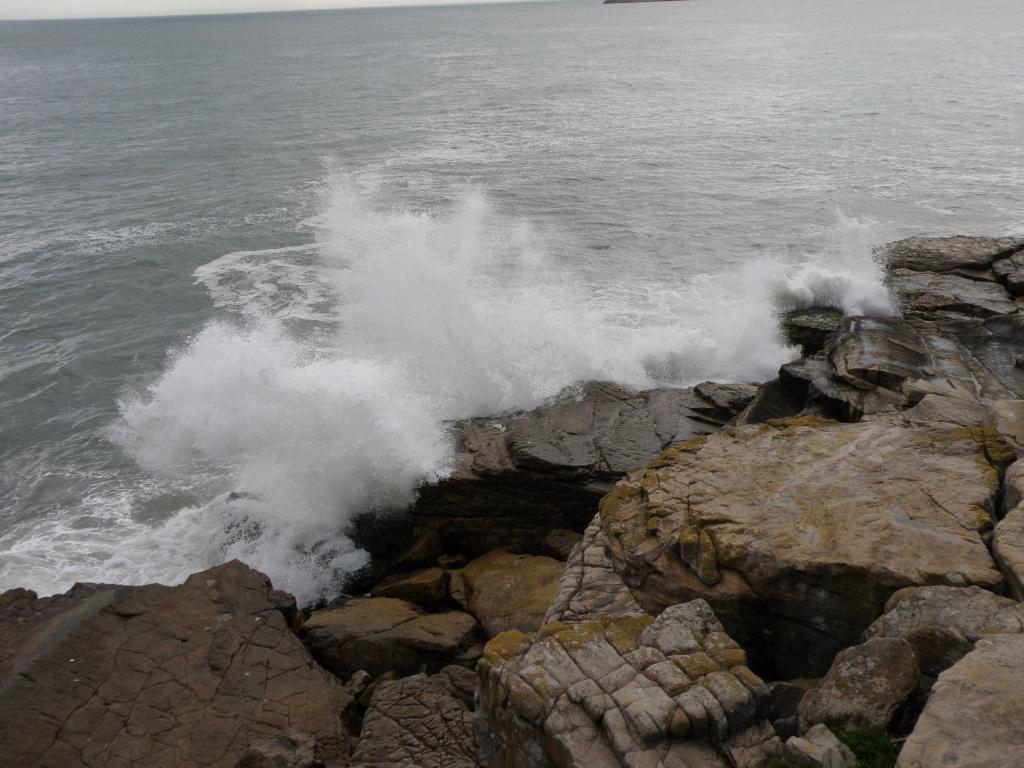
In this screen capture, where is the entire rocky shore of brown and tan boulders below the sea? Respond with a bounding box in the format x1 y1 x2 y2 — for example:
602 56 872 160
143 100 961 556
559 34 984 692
0 238 1024 768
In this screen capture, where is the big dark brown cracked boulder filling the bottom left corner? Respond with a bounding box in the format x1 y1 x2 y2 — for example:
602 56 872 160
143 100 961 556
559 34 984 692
0 561 350 768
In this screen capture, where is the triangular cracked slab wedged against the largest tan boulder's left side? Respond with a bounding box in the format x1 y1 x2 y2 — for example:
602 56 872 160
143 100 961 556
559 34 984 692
544 516 643 624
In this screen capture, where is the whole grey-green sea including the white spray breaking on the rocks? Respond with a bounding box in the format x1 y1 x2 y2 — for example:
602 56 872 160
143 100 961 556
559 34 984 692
0 0 1024 603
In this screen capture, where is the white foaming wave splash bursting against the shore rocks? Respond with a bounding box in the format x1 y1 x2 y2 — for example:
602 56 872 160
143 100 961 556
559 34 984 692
98 177 891 603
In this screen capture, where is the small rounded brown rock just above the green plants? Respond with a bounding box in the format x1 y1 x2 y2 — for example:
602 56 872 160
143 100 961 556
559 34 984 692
798 637 921 732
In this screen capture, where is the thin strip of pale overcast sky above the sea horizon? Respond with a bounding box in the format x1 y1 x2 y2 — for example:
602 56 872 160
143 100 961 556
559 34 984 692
0 0 512 18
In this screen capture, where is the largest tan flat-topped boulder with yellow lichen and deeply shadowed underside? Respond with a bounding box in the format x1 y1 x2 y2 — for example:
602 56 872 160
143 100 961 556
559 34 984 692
601 418 1005 678
